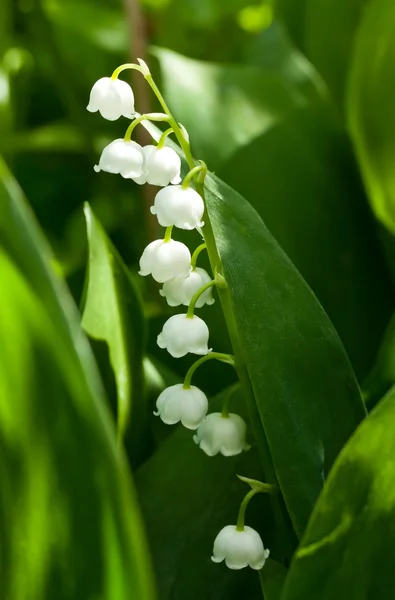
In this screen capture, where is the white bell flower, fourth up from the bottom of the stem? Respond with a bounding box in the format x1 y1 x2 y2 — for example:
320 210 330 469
157 315 211 358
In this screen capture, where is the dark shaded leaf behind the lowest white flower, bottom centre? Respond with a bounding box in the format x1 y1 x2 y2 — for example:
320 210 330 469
136 390 275 600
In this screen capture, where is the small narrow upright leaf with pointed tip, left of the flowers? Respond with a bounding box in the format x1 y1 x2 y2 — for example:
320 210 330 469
82 204 146 448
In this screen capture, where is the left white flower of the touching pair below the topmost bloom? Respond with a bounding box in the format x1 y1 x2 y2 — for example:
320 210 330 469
93 138 144 179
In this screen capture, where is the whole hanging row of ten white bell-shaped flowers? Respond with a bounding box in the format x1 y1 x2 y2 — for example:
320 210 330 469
87 67 267 569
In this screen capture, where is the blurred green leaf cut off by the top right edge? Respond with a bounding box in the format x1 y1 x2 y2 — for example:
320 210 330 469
348 0 395 234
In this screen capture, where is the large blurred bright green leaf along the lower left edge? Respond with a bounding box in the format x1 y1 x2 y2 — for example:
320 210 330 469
0 163 154 600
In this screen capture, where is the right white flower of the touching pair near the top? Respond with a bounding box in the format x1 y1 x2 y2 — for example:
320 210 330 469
134 146 181 186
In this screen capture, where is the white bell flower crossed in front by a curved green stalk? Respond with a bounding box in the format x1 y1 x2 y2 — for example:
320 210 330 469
159 267 214 308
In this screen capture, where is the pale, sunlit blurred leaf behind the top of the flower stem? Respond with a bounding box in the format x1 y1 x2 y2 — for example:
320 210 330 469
154 45 322 169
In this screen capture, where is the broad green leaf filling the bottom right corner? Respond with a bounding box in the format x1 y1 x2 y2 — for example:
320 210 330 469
281 390 395 600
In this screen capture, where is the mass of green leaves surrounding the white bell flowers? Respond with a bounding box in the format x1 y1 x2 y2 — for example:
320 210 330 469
0 0 395 600
